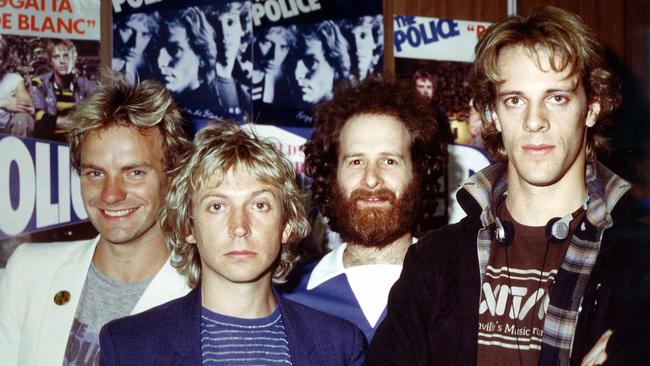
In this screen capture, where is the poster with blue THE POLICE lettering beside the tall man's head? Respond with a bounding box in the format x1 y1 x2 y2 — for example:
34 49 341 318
393 15 490 223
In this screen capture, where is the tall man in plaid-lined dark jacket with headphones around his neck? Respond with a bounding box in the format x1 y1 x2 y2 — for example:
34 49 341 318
367 7 650 365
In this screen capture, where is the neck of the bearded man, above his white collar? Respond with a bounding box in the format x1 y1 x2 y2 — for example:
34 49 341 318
343 233 413 268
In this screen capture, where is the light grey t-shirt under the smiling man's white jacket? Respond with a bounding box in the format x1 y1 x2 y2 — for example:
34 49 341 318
63 264 151 366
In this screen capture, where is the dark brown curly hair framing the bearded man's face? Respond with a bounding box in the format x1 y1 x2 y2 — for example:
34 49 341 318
305 77 447 232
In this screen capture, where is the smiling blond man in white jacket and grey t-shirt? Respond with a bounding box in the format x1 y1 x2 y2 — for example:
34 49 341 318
0 72 191 365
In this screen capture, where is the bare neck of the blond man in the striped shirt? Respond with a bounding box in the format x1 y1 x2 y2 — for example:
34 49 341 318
201 272 277 319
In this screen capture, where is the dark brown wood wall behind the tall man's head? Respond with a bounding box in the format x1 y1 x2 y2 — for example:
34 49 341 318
383 0 650 206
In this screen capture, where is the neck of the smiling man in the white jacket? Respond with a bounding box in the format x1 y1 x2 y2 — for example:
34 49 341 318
93 228 169 283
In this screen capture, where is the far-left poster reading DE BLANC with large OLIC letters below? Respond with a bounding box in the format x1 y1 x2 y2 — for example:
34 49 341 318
0 0 100 268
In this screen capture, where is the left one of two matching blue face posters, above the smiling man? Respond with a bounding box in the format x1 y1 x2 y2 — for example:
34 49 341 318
112 0 253 132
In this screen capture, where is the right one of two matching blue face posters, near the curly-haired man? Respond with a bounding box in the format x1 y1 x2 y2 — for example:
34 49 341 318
252 0 384 137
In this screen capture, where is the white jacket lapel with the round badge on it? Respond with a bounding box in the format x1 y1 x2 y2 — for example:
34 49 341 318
36 236 99 365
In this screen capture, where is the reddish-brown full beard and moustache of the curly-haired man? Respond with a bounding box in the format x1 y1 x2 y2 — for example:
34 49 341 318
330 179 422 248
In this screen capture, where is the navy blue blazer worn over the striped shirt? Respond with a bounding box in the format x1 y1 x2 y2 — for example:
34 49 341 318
99 287 365 366
